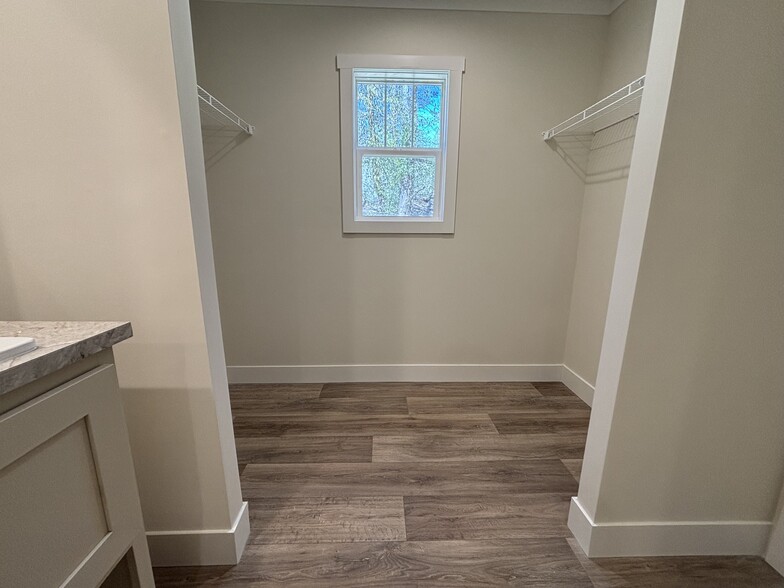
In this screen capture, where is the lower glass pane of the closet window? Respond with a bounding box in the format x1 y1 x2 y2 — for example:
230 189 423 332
362 155 436 217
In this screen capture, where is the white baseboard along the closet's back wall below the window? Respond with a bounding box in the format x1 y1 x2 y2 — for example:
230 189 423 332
227 364 562 384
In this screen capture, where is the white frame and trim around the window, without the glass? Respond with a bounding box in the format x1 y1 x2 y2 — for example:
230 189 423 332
337 54 465 234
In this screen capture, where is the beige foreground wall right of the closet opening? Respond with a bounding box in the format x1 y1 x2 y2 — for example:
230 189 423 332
592 0 784 522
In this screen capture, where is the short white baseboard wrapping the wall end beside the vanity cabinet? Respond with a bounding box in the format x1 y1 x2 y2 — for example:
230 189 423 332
147 502 250 567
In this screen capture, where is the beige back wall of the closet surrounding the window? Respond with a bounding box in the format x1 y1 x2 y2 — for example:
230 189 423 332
192 2 608 365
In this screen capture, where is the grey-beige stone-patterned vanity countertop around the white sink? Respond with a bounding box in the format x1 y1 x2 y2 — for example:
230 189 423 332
0 321 133 394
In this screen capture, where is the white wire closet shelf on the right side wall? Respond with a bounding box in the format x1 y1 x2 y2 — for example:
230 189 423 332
542 76 645 141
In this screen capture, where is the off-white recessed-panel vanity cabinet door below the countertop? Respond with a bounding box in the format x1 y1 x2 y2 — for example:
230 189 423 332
0 365 154 588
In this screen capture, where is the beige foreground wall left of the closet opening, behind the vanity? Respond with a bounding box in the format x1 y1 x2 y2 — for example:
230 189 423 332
0 0 240 552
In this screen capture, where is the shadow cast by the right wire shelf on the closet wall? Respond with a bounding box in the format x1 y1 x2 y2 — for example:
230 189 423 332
548 116 637 184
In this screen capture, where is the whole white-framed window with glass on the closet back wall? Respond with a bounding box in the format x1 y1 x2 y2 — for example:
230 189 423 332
338 55 465 233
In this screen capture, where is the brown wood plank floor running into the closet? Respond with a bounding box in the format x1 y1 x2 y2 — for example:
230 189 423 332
155 382 784 588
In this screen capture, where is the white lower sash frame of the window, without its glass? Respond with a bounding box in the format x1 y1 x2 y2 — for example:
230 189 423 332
354 147 444 223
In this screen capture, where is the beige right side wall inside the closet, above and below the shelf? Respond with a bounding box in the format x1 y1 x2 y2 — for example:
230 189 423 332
564 0 656 385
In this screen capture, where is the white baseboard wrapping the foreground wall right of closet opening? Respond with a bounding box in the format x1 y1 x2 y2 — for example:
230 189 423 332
569 497 771 557
